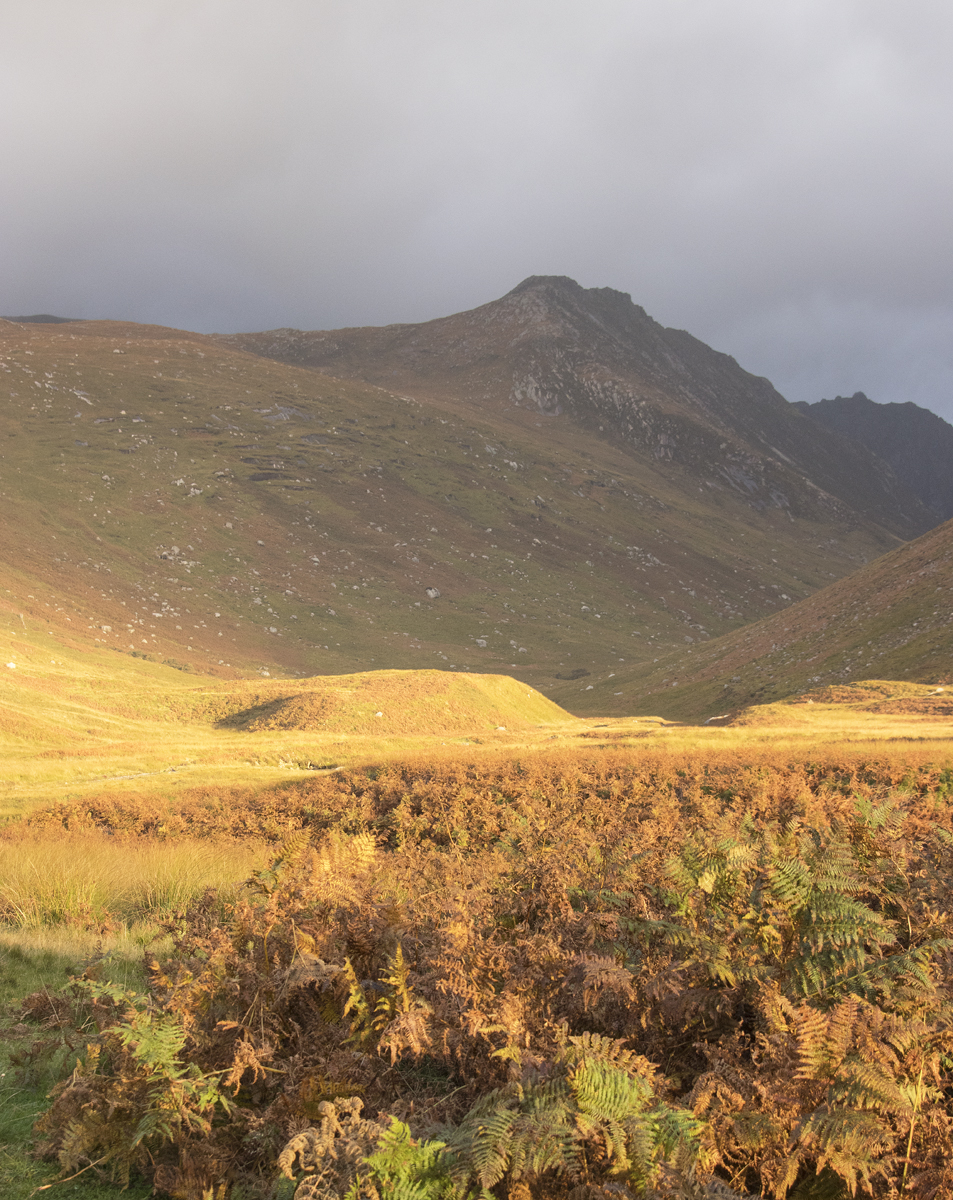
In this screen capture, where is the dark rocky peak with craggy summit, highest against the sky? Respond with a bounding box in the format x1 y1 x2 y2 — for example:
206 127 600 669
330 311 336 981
223 276 936 538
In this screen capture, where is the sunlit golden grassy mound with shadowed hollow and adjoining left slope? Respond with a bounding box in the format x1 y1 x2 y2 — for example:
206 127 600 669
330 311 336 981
0 614 585 816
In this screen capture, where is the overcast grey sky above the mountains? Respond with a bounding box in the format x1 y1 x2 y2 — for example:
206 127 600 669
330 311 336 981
0 0 953 421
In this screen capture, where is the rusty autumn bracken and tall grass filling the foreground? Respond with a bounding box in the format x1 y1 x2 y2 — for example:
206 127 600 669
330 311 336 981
0 685 953 1200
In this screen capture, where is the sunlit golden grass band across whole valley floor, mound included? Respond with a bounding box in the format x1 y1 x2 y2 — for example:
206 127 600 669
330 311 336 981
0 619 953 818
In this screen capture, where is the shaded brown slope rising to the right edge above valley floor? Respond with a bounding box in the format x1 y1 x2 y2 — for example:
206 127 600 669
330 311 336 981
592 511 953 720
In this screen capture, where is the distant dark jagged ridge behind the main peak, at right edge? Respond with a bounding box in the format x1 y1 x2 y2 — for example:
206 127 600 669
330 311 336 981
795 391 953 521
